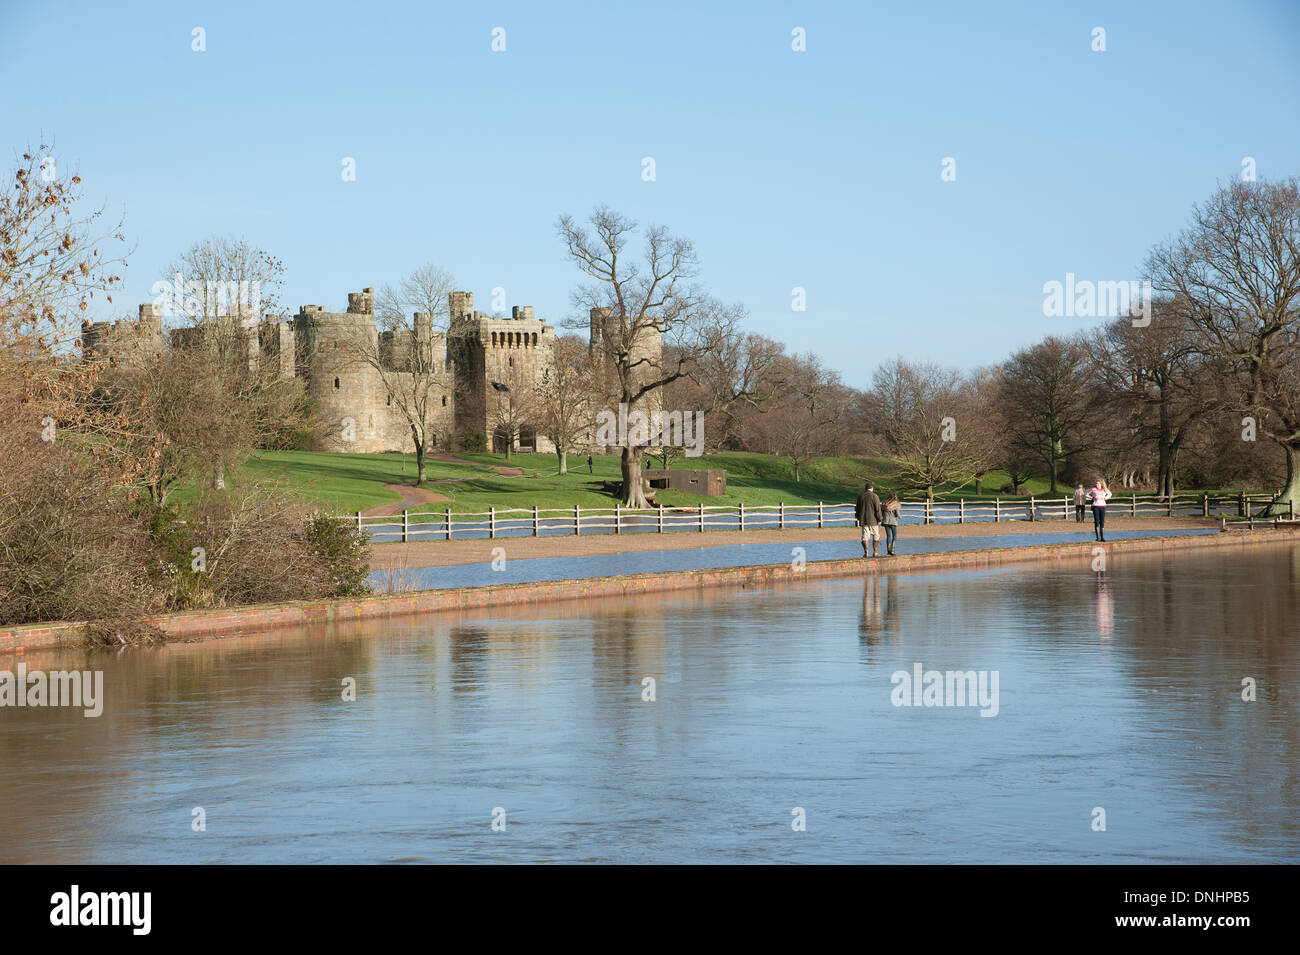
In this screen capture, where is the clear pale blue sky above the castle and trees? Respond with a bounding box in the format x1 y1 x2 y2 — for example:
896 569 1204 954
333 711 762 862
0 0 1300 387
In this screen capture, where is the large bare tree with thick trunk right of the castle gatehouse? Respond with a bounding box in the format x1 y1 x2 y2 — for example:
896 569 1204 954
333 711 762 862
558 207 736 508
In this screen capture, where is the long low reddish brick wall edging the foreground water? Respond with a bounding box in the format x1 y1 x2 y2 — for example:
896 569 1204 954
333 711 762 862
0 528 1300 652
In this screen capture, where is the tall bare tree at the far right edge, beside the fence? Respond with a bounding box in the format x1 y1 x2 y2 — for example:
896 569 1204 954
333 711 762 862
1147 177 1300 502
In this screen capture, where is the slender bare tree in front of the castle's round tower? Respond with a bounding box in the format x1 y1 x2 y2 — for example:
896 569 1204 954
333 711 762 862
347 264 455 485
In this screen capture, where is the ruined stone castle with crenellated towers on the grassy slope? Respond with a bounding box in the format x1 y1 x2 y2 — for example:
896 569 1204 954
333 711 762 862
82 288 662 453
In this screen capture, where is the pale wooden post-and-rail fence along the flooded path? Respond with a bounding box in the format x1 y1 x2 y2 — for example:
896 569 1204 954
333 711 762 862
350 494 1295 542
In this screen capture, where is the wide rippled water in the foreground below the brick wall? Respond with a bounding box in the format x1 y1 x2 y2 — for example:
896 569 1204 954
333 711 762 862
0 544 1300 863
